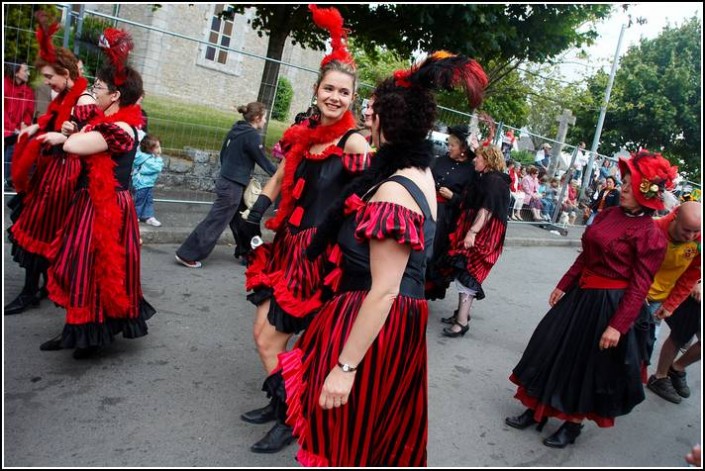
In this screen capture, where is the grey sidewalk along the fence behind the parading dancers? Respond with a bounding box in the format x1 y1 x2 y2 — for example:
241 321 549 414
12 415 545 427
5 189 585 247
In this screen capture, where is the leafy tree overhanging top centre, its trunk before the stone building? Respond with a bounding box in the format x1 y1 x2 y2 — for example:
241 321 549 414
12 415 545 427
226 4 612 129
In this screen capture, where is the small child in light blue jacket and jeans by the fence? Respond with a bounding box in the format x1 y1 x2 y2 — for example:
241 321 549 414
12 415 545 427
132 134 164 227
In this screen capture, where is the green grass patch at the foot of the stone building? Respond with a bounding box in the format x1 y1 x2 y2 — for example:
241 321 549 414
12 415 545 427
142 96 289 156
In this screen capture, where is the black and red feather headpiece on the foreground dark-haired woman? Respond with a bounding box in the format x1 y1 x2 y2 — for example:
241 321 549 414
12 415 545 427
394 51 489 108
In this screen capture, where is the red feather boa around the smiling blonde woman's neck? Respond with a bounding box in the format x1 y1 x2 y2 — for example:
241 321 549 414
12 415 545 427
265 111 356 231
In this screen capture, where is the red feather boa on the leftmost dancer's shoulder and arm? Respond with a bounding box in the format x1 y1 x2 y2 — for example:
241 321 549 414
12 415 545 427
10 77 88 193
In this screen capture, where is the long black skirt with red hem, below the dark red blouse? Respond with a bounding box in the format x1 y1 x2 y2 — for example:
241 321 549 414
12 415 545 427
510 288 651 427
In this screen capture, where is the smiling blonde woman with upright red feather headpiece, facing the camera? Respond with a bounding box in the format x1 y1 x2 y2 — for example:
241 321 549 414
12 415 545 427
242 5 369 453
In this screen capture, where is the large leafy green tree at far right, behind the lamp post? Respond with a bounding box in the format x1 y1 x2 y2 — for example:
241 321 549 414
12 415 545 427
578 17 702 181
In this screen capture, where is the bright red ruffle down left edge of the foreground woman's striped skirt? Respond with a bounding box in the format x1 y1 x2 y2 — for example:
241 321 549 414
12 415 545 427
277 348 329 467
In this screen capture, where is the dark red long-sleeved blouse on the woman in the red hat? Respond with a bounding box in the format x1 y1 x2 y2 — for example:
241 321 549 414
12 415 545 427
557 207 668 334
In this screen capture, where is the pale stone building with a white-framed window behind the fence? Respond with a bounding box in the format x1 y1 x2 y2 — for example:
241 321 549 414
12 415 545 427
86 3 323 119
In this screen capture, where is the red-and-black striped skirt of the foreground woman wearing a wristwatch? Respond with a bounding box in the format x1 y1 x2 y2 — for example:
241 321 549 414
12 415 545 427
279 291 428 467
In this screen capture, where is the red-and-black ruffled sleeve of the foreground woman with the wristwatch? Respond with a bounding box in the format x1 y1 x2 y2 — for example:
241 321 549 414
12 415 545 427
355 201 424 250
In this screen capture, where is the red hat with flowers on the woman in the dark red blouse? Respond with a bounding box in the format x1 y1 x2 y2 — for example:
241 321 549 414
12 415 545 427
619 149 678 210
